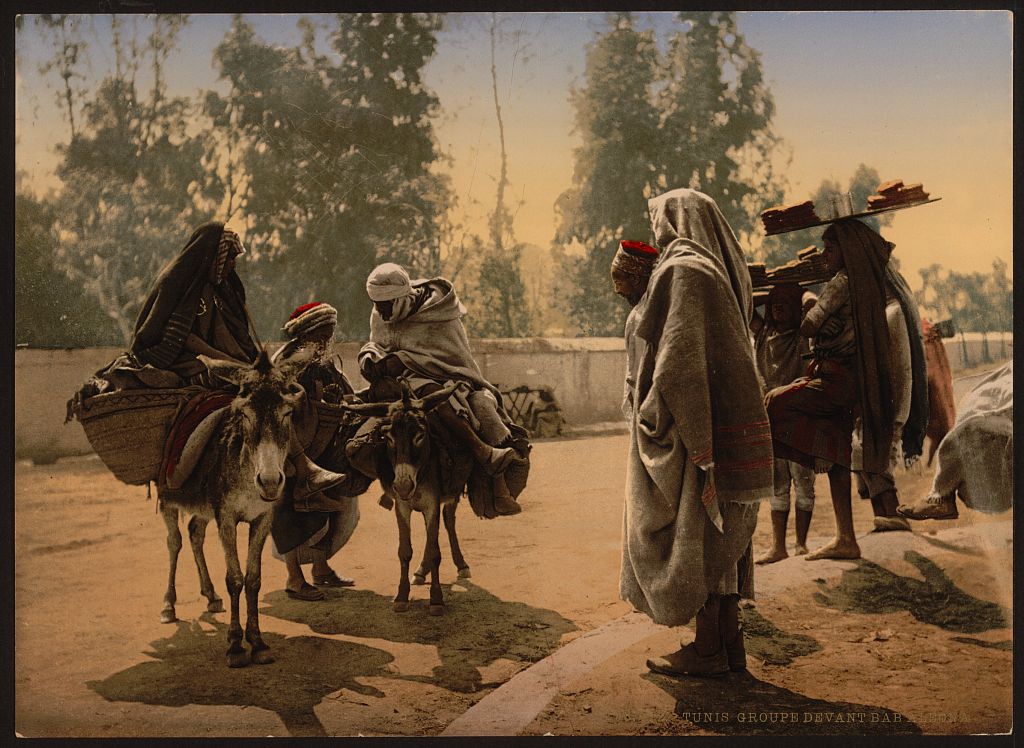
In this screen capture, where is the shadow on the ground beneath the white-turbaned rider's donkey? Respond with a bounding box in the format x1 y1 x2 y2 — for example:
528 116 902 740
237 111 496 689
260 580 577 693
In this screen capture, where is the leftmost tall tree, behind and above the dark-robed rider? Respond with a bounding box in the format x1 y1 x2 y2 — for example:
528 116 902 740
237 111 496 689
46 15 205 342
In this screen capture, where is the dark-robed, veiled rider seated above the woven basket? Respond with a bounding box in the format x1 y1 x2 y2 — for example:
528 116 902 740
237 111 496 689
129 221 258 386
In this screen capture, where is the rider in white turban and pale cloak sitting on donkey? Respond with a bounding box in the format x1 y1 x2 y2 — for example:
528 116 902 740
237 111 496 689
358 262 521 514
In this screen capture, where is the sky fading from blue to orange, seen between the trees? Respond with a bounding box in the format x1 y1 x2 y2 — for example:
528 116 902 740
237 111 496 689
16 10 1013 287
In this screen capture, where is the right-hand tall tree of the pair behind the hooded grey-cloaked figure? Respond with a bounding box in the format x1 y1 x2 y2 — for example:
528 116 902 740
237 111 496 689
657 11 782 251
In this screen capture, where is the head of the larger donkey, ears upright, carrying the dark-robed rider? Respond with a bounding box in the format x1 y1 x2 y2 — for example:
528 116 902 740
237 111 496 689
231 350 304 501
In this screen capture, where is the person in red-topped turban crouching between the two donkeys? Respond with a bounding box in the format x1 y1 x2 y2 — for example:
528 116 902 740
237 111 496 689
271 301 371 600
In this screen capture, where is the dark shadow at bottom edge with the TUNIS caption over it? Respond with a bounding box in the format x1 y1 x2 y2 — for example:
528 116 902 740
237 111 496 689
641 671 922 736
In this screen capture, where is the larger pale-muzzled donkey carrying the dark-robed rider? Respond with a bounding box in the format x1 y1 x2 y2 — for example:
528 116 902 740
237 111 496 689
158 350 303 667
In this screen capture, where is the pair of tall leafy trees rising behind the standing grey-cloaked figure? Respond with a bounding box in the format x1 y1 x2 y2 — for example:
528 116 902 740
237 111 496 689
556 12 782 335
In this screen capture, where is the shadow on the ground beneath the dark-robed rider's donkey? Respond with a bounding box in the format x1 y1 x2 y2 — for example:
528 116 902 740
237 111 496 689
86 614 394 737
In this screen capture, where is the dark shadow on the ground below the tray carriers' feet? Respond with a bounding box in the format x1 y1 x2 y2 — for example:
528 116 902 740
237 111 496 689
814 550 1009 633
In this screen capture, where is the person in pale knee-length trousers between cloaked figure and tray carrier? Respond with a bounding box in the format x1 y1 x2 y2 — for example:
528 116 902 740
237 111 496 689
755 283 817 564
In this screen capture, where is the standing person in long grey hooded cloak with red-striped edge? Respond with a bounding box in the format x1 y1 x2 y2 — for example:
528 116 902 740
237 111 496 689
618 190 772 676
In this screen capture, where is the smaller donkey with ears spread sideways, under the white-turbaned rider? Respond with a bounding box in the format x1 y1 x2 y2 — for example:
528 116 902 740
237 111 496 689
341 380 469 616
